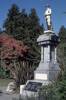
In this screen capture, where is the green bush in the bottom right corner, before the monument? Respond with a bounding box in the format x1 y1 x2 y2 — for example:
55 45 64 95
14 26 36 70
36 80 66 100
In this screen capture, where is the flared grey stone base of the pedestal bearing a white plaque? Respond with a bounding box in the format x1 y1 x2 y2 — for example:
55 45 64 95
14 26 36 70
34 62 60 81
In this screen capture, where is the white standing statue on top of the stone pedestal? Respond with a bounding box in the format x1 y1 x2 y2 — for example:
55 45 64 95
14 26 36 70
45 6 52 30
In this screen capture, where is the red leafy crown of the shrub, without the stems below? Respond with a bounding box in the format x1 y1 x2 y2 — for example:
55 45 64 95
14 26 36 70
0 34 28 59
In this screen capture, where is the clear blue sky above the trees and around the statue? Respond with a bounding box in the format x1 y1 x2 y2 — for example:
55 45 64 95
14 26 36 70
0 0 66 33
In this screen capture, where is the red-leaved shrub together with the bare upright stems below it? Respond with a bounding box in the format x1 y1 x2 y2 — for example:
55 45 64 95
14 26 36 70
0 34 33 85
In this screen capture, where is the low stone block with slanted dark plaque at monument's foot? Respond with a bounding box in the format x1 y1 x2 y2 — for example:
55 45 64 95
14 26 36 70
20 80 50 97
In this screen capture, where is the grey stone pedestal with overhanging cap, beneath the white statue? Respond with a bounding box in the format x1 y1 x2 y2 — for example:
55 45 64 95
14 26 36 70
34 30 60 81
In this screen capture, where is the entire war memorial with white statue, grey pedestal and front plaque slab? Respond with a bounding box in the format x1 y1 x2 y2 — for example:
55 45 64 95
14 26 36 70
20 7 60 96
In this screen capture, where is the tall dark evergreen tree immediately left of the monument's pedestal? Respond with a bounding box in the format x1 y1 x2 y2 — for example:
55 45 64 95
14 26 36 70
27 8 43 61
